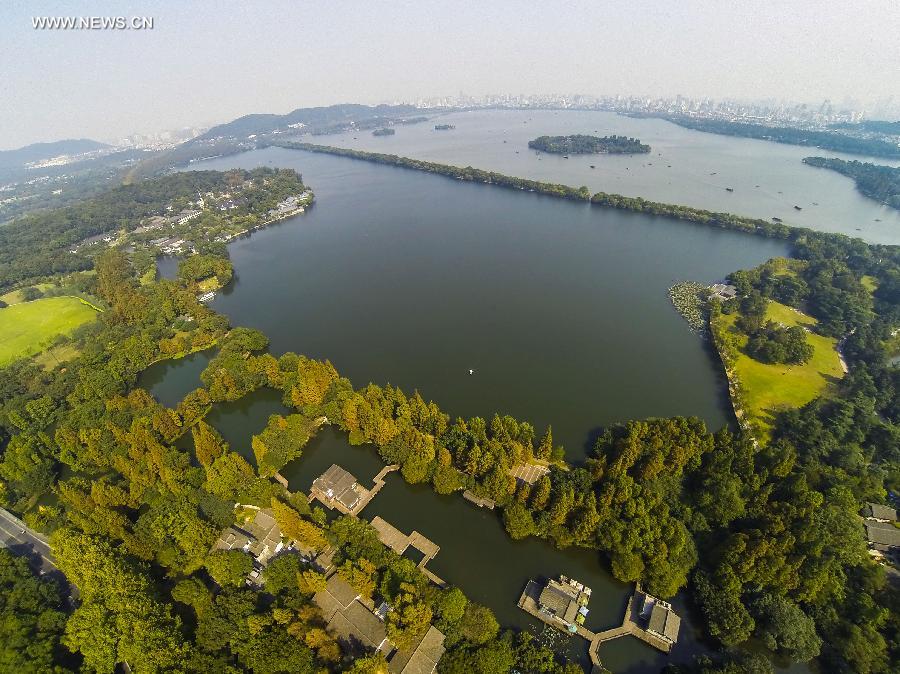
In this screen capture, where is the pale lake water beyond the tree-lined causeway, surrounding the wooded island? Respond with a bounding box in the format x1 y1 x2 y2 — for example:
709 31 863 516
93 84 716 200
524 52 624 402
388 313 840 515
314 110 900 244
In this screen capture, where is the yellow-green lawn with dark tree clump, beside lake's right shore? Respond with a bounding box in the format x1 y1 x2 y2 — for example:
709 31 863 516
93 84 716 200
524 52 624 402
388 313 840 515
721 302 844 440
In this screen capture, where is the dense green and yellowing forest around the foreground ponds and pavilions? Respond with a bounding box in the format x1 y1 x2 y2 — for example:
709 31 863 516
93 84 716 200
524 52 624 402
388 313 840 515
0 158 900 674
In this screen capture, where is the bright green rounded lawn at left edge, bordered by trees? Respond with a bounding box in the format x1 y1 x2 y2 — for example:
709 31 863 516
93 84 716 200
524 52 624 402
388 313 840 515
0 297 97 367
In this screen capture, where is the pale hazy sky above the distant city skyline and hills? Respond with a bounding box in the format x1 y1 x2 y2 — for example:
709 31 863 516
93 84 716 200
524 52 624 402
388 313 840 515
0 0 900 149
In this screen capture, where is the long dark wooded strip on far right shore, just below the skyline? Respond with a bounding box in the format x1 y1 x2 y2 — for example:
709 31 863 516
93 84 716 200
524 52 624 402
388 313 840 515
635 115 900 159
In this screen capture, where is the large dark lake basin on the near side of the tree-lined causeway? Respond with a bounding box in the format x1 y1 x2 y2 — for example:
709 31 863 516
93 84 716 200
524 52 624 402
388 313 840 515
160 148 787 460
